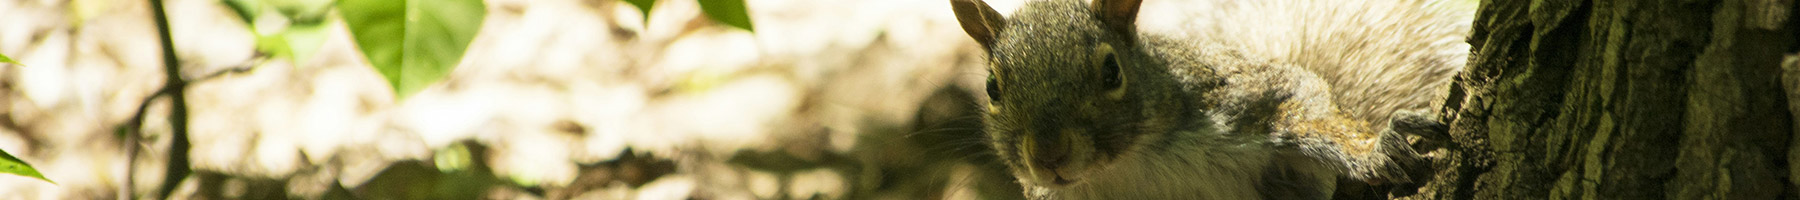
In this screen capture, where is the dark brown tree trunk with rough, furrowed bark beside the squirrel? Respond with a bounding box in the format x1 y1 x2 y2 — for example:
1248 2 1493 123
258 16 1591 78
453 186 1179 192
1417 0 1800 200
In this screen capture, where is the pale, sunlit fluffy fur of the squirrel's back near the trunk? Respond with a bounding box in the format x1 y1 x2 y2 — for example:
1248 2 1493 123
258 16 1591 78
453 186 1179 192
1163 0 1474 130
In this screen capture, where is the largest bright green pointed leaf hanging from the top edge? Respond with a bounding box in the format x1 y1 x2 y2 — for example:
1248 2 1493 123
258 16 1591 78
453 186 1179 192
337 0 488 99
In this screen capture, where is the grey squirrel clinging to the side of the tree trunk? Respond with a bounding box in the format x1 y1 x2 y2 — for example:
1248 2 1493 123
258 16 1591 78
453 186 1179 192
950 0 1462 200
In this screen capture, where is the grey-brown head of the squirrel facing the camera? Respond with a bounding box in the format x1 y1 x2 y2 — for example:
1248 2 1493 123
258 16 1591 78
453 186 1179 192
950 0 1166 187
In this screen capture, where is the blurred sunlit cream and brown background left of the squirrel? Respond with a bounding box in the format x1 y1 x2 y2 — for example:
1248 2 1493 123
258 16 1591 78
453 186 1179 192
0 0 1019 200
